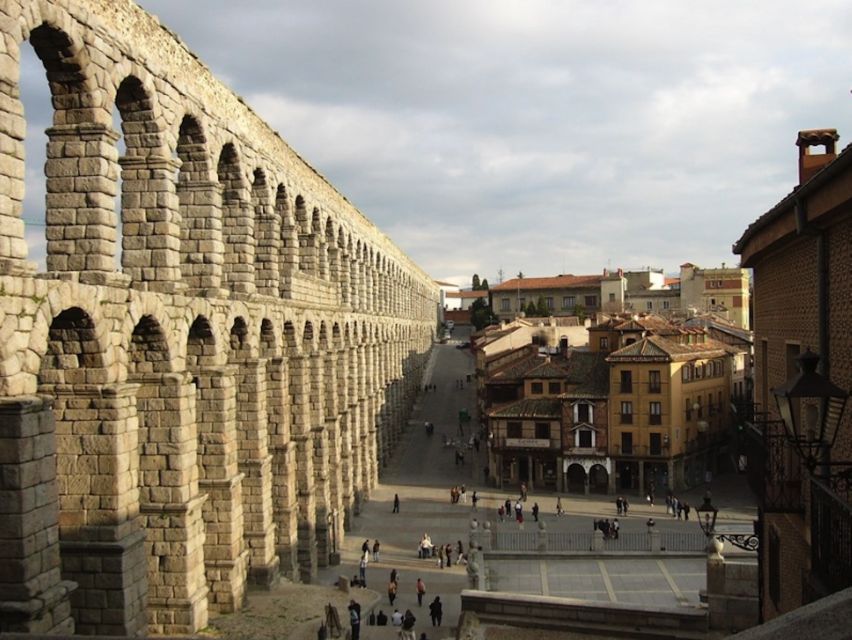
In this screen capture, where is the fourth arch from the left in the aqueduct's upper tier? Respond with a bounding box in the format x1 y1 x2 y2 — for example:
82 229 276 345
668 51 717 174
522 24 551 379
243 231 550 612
216 142 255 294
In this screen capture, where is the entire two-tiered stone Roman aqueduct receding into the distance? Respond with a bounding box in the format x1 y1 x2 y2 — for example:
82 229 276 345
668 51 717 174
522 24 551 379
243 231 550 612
0 0 438 635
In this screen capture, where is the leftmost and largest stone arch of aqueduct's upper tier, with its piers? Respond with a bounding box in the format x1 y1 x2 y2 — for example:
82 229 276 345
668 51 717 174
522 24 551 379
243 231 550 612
11 18 115 273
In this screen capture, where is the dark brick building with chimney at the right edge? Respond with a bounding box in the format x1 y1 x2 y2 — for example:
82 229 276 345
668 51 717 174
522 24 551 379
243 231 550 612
734 129 852 620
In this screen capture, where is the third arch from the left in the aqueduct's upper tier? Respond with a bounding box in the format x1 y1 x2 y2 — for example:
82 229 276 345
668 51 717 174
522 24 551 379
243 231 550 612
175 114 225 294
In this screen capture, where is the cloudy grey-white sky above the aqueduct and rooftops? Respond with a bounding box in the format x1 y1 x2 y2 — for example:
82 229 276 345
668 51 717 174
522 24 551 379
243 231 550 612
22 0 852 285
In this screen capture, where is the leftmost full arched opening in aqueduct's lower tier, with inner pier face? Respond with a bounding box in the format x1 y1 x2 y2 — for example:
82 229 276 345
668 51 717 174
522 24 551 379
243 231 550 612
39 307 147 635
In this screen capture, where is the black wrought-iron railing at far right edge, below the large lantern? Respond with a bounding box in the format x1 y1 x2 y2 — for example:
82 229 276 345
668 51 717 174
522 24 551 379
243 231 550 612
811 476 852 595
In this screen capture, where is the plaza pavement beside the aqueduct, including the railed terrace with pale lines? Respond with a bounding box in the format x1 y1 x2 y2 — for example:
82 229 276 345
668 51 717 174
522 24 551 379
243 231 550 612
317 329 756 640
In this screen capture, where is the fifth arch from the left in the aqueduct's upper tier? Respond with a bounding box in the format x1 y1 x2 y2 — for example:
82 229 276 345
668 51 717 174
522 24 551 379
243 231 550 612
251 168 281 297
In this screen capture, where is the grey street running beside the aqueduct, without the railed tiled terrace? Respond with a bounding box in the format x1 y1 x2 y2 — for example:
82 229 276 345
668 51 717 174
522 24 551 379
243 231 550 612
318 328 755 638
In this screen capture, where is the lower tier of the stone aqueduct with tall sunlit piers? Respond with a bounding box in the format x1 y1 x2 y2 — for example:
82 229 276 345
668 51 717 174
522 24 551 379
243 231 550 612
0 276 434 635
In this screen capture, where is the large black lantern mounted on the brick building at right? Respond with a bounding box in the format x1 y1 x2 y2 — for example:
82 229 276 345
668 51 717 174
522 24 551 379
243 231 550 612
772 348 849 475
